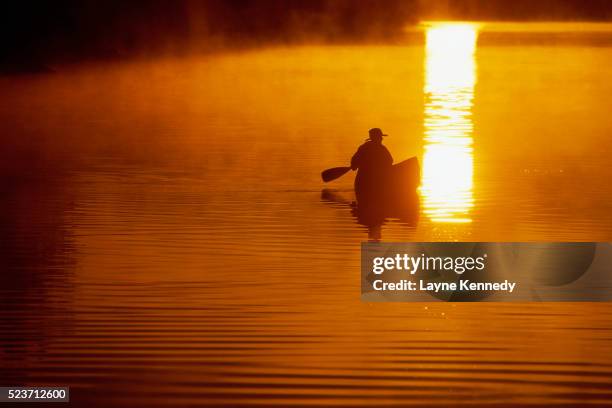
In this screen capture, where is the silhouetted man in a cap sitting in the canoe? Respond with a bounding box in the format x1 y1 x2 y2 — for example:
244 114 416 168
351 128 393 204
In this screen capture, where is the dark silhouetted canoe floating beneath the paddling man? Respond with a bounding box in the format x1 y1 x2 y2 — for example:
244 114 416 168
355 157 421 210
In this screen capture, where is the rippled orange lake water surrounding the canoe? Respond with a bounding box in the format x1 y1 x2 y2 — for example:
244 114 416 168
0 24 612 407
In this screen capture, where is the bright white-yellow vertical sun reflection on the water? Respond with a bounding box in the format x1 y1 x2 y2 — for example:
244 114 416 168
421 23 478 222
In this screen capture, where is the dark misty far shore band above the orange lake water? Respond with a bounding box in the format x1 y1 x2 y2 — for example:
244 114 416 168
0 0 612 71
